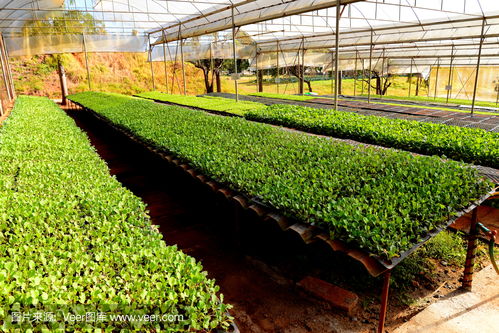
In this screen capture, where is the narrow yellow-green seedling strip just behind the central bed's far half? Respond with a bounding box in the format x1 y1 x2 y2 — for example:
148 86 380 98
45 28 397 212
135 91 266 116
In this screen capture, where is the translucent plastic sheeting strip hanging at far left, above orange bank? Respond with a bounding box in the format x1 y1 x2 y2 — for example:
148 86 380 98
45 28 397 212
5 34 148 56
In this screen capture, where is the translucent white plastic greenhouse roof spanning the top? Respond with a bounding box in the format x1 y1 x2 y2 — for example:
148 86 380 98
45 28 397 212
0 0 499 66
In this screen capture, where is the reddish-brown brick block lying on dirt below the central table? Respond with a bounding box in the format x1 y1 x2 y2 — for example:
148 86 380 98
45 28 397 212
298 276 359 315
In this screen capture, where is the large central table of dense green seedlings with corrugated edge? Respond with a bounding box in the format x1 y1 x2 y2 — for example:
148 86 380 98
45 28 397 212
70 93 492 261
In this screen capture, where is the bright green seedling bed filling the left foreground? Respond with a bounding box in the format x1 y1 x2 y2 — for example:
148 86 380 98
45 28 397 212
0 97 232 332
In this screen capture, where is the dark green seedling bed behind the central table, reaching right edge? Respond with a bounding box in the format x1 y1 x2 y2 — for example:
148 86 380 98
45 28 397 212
245 105 499 168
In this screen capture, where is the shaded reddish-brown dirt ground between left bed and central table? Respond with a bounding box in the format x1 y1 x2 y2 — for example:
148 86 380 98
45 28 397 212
62 104 492 333
